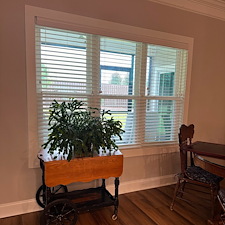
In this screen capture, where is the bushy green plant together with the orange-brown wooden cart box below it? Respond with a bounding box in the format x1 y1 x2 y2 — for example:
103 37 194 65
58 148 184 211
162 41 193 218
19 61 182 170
39 99 124 186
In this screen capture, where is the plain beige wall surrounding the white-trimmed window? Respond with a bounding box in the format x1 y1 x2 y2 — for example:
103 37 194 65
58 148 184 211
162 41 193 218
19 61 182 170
0 0 225 204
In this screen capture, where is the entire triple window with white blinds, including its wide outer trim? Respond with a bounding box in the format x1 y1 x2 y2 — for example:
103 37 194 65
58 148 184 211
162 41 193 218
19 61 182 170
25 6 193 168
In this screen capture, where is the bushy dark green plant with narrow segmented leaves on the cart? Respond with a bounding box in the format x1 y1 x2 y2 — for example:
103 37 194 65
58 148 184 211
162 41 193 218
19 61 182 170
42 99 124 161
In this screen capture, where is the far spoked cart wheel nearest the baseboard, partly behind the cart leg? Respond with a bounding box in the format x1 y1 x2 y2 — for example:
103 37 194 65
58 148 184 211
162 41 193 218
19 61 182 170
36 185 68 208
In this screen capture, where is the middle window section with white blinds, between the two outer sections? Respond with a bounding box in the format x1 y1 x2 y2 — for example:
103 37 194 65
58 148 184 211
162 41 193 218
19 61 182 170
100 37 138 145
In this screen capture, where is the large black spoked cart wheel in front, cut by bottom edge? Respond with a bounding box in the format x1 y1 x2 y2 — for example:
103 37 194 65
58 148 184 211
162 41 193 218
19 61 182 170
41 199 78 225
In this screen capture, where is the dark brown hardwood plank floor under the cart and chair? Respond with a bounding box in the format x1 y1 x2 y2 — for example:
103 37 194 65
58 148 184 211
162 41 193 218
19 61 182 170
0 184 216 225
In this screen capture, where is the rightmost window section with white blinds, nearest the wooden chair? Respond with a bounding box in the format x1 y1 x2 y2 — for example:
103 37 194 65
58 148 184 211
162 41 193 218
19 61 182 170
145 45 187 144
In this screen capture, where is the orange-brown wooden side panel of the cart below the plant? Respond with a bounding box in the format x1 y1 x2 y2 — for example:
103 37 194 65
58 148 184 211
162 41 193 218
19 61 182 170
43 151 123 187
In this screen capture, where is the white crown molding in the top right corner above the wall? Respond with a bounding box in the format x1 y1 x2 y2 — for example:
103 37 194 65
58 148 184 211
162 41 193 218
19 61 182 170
148 0 225 21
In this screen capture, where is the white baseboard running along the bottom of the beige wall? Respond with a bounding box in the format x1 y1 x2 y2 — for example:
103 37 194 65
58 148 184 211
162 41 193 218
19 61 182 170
0 174 175 218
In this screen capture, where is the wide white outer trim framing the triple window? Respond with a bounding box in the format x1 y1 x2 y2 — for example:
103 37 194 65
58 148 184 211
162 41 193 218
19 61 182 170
25 5 194 168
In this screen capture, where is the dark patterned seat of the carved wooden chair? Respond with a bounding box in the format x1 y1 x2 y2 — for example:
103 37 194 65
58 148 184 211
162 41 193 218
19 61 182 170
185 166 223 185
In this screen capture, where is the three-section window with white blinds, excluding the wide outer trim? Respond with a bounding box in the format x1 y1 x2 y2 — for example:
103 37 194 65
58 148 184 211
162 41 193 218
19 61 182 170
36 25 187 149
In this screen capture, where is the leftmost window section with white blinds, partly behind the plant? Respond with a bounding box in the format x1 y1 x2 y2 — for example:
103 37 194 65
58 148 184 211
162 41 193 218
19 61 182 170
36 26 93 145
